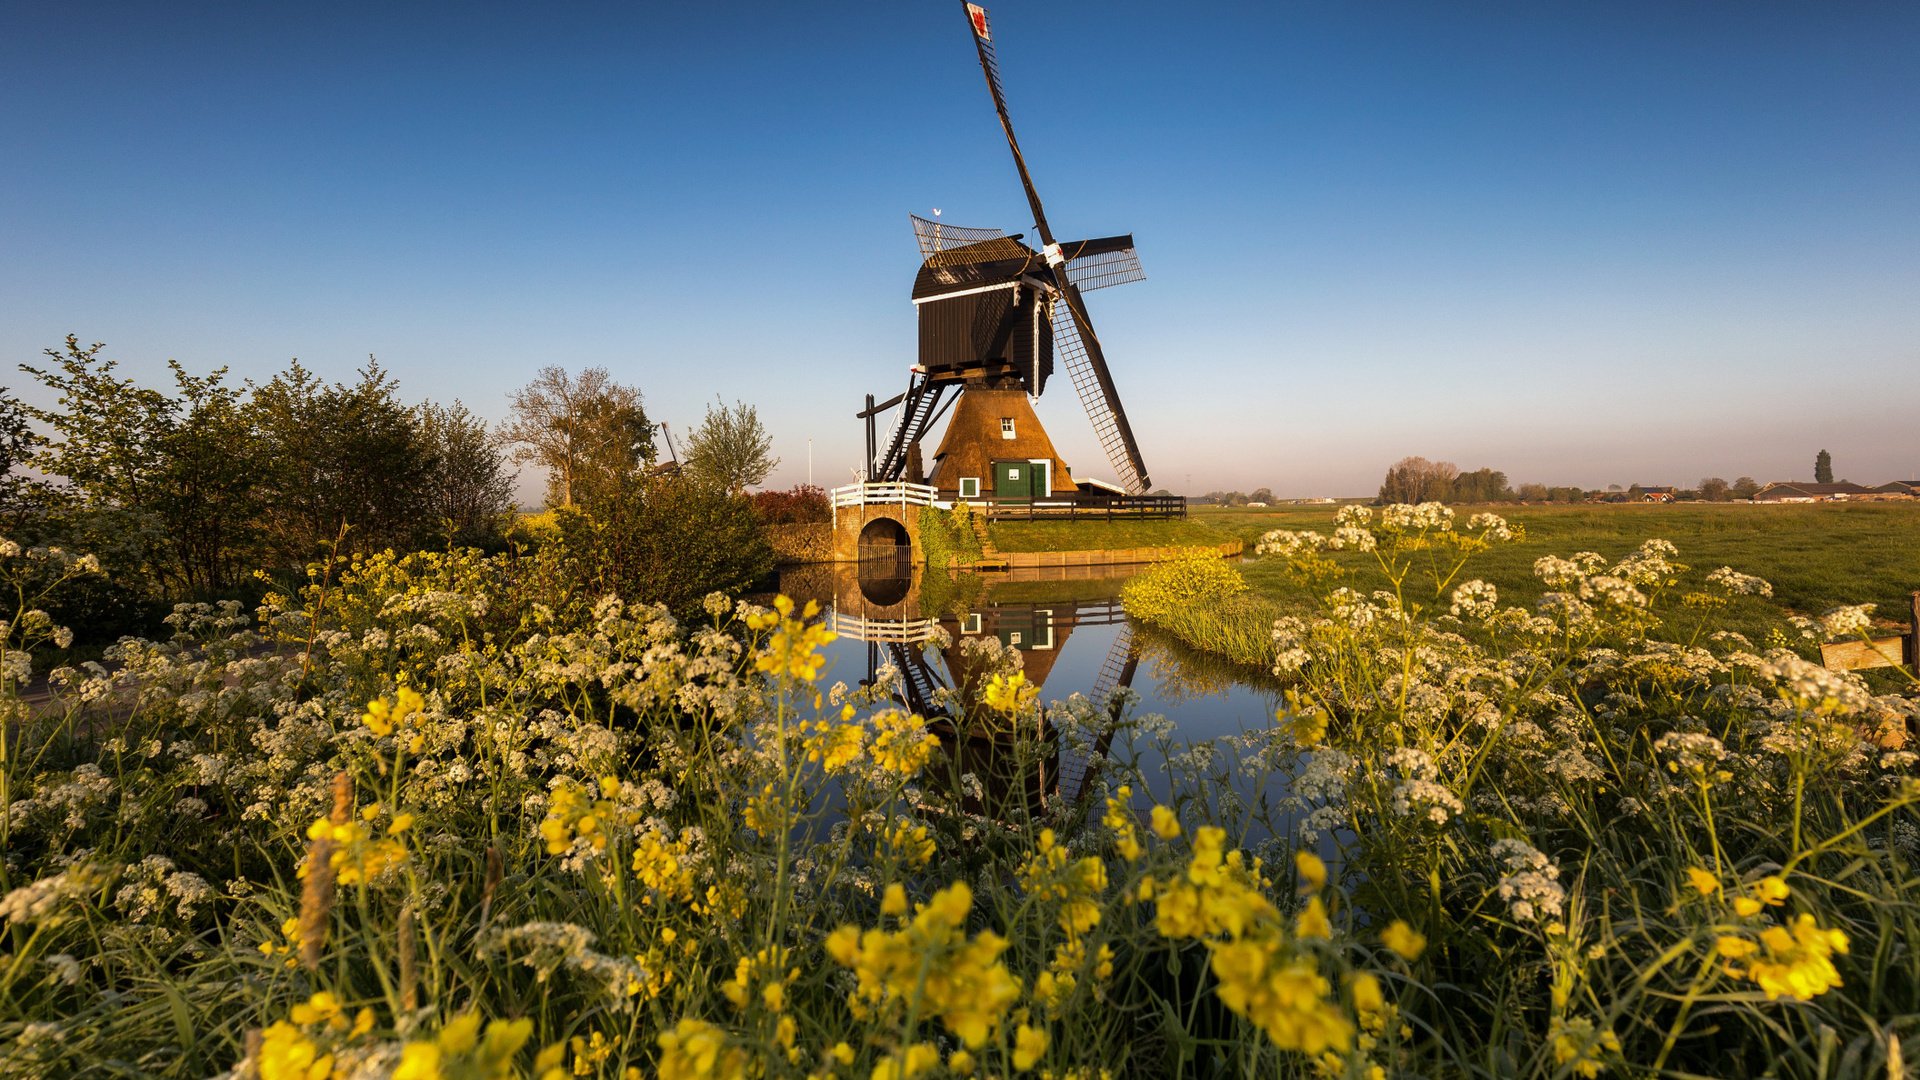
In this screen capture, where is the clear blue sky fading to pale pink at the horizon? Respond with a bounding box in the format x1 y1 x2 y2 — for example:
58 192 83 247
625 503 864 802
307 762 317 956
0 0 1920 496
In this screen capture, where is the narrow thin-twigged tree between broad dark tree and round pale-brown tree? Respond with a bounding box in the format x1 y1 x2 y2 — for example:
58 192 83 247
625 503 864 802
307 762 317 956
420 400 513 548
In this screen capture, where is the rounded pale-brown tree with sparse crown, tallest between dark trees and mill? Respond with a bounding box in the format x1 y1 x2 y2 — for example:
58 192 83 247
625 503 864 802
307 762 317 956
499 365 653 505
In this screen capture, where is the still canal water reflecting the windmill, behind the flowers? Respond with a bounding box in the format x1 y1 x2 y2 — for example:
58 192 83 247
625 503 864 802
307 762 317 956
780 559 1281 798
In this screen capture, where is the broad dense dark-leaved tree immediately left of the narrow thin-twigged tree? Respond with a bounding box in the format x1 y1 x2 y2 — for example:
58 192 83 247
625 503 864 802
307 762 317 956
248 357 432 567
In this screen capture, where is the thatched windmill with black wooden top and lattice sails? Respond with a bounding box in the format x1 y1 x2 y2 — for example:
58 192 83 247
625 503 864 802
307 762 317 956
856 4 1150 498
